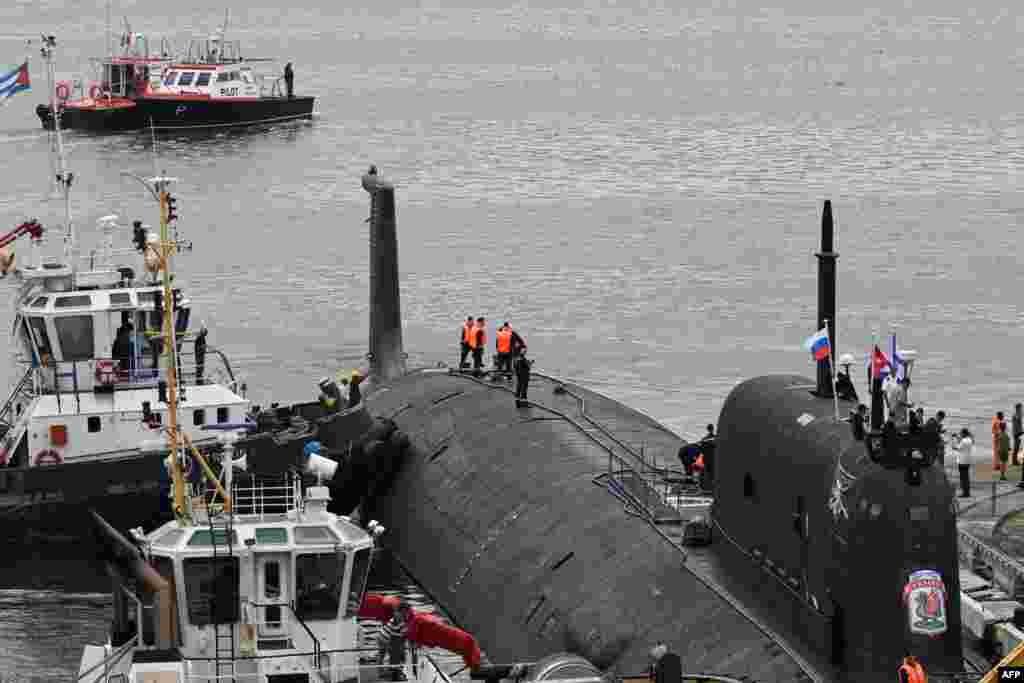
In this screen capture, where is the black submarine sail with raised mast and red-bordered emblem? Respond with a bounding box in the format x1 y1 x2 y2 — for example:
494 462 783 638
713 203 963 683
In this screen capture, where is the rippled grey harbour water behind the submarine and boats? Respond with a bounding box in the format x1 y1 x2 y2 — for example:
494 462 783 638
0 0 1024 681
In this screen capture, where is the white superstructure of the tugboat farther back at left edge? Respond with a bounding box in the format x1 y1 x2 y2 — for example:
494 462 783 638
0 269 249 468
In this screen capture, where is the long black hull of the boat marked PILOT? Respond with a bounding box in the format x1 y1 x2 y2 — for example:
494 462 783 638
36 97 315 132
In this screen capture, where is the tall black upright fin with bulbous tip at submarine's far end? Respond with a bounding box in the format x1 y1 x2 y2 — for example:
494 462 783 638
362 166 406 381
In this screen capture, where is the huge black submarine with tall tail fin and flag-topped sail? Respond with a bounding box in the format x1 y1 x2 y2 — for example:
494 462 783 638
350 168 963 683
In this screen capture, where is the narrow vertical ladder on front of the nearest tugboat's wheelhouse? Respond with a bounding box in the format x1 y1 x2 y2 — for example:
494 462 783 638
209 505 240 683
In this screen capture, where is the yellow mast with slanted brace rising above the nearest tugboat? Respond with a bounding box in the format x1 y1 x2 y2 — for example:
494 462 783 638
122 172 232 526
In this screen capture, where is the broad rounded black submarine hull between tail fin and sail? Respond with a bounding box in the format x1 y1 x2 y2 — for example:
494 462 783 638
366 370 836 683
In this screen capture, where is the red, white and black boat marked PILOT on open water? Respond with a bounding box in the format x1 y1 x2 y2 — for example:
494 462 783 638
37 19 315 132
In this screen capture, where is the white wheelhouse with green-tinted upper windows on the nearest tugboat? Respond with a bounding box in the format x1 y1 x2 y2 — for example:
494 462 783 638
79 476 403 683
